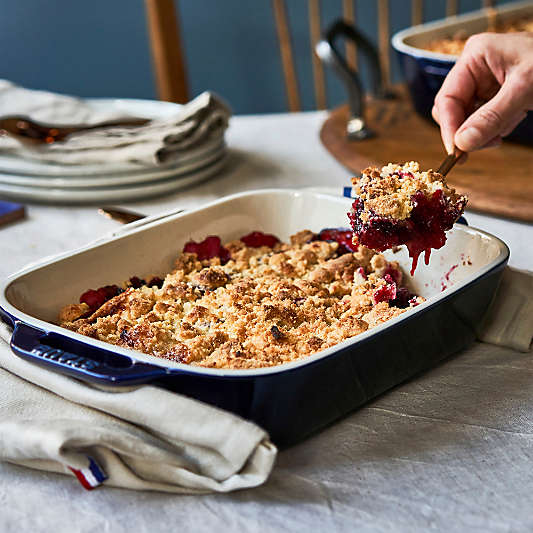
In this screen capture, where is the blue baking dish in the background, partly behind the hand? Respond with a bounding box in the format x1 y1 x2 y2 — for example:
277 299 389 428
392 1 533 145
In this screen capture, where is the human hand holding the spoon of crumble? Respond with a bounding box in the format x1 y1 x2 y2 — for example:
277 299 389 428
432 32 533 154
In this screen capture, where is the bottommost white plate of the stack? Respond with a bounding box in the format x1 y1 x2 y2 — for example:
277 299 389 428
0 153 228 204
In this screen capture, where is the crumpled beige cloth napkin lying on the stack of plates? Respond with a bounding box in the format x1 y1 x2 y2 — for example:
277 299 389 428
0 80 231 165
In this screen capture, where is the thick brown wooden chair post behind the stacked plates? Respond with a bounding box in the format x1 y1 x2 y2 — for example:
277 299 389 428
145 0 189 103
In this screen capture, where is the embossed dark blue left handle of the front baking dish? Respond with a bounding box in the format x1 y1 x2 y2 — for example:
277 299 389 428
10 321 167 385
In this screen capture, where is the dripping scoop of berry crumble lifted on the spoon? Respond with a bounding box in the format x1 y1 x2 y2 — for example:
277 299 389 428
348 161 467 275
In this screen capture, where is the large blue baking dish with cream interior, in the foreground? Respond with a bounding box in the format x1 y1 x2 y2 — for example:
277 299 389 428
0 190 509 447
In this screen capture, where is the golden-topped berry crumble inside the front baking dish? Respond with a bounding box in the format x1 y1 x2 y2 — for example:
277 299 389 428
59 228 424 369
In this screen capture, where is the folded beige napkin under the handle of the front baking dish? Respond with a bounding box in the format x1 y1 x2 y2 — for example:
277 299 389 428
0 321 277 493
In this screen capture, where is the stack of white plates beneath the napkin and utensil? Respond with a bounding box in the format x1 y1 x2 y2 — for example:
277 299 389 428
0 99 227 204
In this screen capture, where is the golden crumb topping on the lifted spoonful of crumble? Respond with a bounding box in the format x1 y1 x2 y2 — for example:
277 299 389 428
352 161 466 222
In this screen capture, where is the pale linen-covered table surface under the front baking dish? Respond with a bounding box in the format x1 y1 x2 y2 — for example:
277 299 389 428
0 112 533 533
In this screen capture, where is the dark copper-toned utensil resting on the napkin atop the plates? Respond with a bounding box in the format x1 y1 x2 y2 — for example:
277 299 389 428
0 115 150 144
